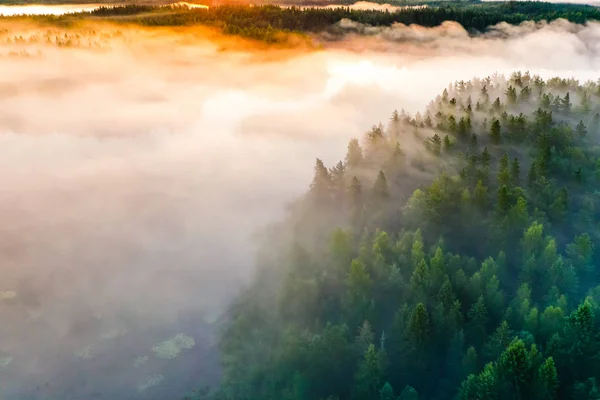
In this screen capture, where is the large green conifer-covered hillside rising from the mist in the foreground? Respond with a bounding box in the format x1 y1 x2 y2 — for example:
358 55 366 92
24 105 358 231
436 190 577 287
191 73 600 400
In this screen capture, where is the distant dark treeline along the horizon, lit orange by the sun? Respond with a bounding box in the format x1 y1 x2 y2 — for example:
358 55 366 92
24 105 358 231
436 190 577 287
17 2 600 42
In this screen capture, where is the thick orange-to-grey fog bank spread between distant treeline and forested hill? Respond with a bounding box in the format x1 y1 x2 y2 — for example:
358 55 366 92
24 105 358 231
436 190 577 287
0 9 600 399
